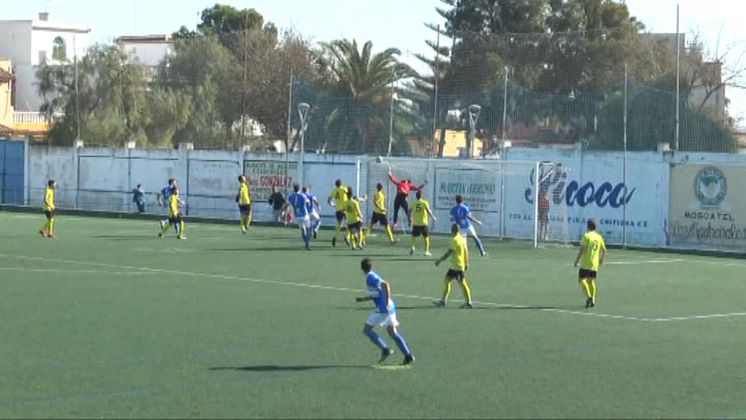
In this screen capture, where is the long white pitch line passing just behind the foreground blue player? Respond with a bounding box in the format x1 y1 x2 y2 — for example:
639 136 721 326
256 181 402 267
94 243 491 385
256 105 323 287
0 254 746 323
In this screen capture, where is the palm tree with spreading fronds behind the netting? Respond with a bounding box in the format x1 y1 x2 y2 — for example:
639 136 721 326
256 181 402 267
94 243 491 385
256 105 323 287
322 39 417 152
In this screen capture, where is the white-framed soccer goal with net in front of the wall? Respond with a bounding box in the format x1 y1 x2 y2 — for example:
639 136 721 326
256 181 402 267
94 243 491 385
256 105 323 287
357 157 573 247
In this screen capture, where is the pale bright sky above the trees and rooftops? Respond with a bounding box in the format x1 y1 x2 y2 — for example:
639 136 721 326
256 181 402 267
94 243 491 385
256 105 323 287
10 0 746 125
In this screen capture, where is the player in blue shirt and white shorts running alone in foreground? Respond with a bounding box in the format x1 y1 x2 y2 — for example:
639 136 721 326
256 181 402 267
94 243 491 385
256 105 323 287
355 258 414 365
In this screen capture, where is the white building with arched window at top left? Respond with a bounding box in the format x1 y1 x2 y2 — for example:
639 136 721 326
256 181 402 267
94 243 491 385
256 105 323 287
0 13 91 111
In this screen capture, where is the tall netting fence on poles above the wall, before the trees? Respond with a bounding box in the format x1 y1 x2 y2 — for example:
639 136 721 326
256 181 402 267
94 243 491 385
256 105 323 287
33 29 736 157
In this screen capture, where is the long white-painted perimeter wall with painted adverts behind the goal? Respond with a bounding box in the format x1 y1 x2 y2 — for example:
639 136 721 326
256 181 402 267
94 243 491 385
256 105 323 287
26 146 746 246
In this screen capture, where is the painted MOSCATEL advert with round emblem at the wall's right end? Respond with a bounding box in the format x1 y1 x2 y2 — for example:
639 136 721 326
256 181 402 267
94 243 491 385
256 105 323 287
669 165 746 250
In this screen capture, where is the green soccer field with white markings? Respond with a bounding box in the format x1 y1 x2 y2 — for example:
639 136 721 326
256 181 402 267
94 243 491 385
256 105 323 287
0 213 746 418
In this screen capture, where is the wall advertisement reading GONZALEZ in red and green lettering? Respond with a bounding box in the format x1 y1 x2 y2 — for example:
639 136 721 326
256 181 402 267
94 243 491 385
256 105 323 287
244 160 298 201
